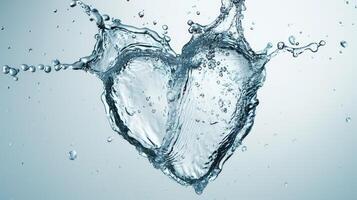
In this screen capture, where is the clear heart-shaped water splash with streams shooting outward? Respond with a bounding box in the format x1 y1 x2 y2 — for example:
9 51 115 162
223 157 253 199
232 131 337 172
3 0 325 194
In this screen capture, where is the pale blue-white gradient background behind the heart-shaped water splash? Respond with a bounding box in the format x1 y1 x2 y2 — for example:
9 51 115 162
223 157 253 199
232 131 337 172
0 0 357 200
